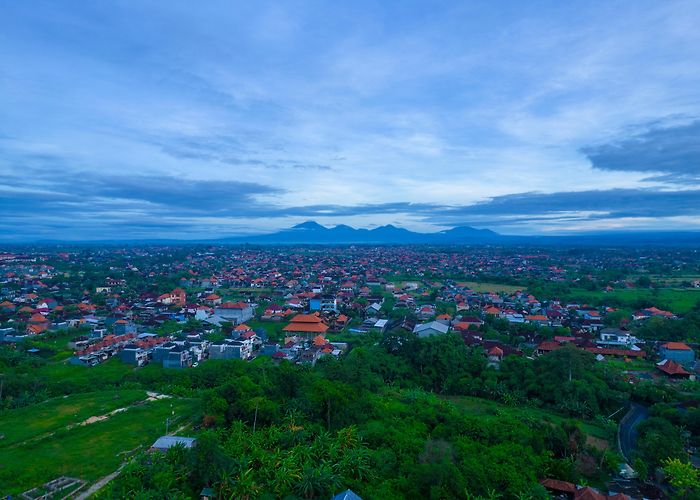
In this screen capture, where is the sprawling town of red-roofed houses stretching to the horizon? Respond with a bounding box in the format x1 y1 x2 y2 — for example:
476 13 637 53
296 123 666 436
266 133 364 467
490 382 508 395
0 246 700 498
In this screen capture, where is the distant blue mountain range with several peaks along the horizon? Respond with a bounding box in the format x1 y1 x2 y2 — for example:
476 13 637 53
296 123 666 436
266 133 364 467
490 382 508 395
212 221 700 247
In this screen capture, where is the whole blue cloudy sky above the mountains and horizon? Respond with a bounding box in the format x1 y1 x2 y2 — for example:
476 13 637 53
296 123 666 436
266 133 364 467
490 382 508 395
0 0 700 242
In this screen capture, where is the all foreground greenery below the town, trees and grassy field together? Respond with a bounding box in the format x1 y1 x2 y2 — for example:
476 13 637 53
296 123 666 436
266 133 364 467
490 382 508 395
0 331 696 498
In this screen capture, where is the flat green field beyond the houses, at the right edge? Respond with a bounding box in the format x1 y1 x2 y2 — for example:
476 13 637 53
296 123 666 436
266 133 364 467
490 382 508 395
569 288 700 314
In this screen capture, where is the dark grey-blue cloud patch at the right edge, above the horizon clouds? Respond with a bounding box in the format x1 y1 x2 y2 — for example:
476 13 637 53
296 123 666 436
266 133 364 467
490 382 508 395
581 120 700 184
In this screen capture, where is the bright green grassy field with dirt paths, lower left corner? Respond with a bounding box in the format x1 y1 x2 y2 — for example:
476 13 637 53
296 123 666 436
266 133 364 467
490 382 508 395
0 390 195 495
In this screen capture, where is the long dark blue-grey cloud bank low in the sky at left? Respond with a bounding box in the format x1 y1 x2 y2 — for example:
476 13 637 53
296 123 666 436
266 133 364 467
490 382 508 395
0 157 284 223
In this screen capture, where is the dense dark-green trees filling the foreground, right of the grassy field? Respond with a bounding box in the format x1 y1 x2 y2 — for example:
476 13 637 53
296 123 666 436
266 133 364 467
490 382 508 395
58 332 627 498
